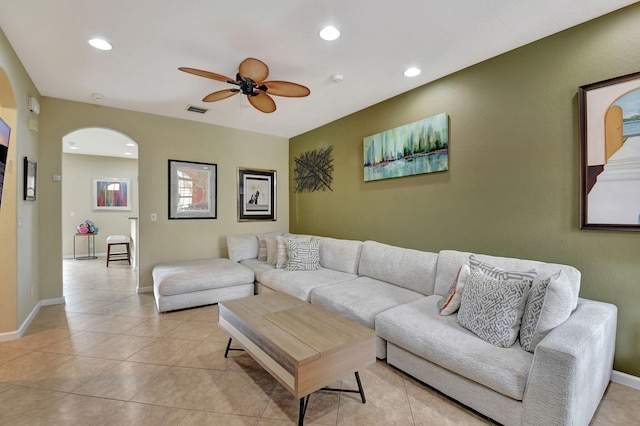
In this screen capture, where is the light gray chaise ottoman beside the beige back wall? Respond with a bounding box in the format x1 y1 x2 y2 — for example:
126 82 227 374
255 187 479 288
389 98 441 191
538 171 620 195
152 258 254 312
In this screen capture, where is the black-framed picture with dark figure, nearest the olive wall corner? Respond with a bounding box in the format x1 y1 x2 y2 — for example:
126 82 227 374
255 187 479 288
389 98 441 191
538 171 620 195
238 168 276 222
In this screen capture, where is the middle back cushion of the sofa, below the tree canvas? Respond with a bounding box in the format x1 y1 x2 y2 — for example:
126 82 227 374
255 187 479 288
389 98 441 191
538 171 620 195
358 241 438 296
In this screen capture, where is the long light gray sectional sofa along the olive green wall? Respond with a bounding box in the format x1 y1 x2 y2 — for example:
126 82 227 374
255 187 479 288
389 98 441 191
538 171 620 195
227 234 617 425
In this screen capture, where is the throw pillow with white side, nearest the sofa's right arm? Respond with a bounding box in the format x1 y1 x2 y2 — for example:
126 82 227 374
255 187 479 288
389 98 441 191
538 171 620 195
520 271 573 352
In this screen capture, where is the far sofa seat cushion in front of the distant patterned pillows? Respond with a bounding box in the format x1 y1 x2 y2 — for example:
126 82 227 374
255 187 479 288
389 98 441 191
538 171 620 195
256 267 358 302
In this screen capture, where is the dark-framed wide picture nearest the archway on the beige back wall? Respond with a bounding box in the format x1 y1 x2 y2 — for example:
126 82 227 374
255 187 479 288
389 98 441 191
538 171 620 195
169 160 218 219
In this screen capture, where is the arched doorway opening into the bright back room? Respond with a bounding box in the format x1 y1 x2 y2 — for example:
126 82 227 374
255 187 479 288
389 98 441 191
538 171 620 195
61 127 139 291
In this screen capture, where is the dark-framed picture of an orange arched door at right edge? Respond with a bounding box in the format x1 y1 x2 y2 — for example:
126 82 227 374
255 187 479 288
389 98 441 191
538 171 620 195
578 72 640 231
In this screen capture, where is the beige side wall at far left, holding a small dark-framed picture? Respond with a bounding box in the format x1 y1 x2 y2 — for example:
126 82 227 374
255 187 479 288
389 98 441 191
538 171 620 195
0 26 40 339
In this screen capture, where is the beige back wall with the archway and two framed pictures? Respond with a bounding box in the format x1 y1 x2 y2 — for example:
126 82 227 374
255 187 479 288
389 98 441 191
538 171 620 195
38 97 289 299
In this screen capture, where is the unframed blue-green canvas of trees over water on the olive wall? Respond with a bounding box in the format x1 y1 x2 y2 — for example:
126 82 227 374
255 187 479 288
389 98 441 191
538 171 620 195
363 112 449 182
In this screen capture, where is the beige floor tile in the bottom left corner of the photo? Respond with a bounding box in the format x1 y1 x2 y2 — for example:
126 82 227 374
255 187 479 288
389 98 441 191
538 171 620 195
0 386 65 425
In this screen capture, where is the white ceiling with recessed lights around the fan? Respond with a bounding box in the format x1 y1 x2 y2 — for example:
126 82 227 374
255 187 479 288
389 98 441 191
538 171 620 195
0 0 635 146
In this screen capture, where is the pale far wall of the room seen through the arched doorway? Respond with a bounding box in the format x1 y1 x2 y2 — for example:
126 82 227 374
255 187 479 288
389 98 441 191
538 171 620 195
62 154 138 257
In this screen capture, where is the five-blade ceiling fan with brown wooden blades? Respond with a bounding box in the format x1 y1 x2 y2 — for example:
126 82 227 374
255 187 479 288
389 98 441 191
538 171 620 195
178 58 311 113
